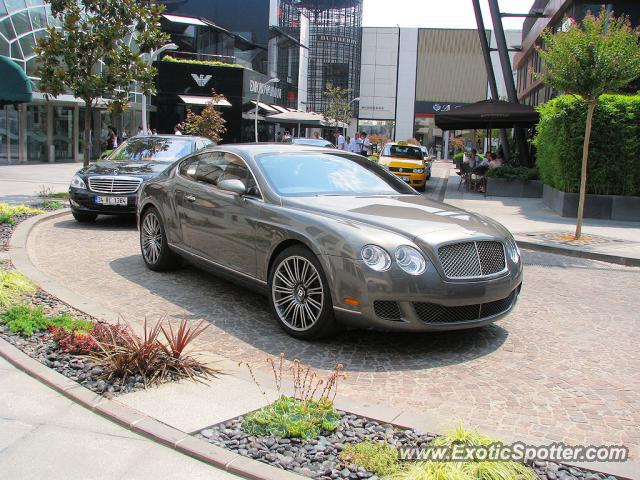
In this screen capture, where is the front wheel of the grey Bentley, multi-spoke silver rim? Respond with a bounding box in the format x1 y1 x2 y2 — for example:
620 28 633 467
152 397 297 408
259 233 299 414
269 246 335 340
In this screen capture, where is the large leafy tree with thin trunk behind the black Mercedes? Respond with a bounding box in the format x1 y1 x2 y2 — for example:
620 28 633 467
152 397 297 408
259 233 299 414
36 0 168 166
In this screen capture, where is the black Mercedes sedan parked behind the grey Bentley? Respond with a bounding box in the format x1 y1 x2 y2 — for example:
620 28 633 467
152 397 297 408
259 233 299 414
69 135 213 222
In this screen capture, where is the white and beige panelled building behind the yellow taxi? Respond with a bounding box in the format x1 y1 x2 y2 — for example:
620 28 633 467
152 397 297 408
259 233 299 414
357 27 489 156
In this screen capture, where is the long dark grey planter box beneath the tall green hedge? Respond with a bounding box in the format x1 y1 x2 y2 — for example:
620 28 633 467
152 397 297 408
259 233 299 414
543 185 640 222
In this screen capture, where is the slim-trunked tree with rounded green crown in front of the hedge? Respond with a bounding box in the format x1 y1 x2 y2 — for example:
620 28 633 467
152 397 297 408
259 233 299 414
537 8 640 240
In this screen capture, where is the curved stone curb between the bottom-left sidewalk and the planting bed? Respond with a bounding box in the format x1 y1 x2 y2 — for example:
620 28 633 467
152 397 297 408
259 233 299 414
0 338 308 480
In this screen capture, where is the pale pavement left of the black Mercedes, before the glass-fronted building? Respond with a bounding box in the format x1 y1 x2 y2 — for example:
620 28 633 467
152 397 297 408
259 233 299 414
0 163 82 203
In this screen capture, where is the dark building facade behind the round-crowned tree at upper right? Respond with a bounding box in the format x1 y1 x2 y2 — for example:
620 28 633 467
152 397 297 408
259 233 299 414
514 0 640 106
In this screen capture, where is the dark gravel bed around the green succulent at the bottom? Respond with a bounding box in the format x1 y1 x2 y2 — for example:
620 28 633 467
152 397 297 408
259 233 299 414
194 412 617 480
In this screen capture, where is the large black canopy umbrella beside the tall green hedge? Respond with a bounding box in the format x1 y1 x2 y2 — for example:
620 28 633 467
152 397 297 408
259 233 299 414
435 100 540 130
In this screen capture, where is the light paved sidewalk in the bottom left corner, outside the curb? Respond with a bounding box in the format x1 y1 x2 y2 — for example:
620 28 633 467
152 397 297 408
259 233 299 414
0 358 241 480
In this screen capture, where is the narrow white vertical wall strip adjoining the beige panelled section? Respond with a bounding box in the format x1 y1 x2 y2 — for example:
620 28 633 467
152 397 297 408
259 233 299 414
395 28 418 140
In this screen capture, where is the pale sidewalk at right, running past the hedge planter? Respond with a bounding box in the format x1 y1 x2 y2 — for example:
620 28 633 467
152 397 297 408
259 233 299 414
432 164 640 259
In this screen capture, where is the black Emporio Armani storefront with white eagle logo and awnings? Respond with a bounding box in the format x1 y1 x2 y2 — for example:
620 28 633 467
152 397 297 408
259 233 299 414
150 57 296 143
